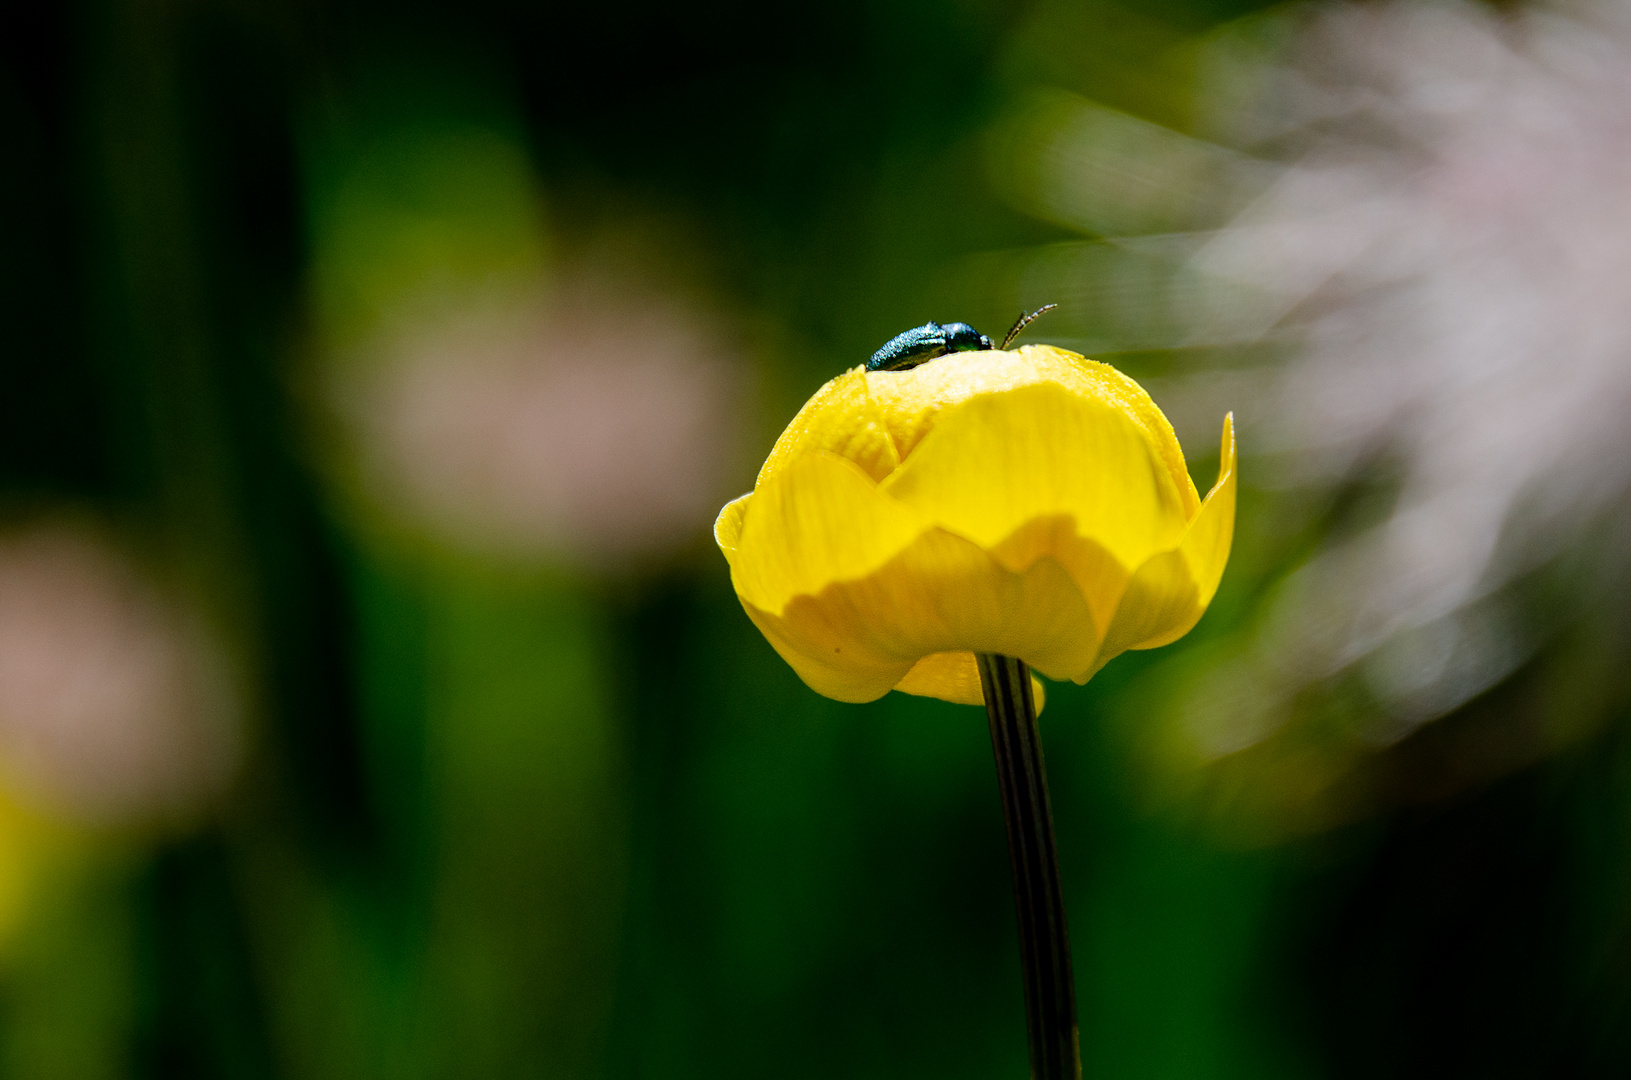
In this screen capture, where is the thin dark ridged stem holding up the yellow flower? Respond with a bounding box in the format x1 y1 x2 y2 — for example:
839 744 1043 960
975 653 1081 1080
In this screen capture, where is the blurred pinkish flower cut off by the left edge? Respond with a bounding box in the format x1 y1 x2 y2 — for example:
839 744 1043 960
0 524 241 824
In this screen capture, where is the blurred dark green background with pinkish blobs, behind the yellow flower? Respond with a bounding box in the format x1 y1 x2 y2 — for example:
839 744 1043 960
0 0 1631 1080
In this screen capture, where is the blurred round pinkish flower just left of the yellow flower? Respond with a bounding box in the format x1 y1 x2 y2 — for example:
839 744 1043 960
336 274 740 566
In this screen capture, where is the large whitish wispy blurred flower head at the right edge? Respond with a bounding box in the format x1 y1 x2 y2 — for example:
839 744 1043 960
1194 3 1631 750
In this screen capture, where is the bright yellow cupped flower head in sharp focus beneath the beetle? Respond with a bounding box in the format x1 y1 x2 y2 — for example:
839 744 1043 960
714 346 1235 705
